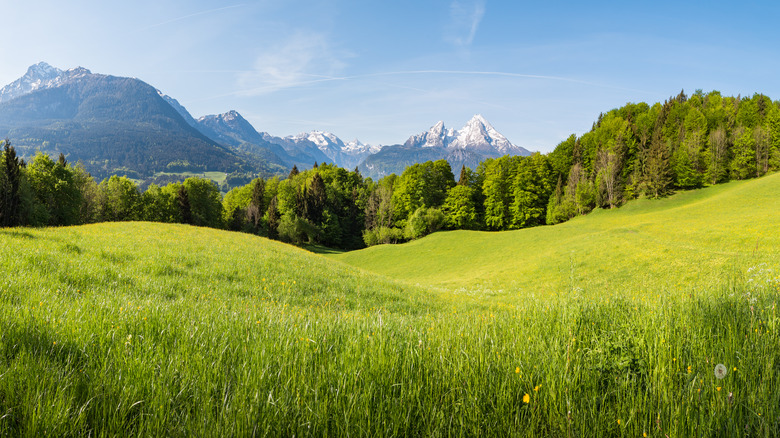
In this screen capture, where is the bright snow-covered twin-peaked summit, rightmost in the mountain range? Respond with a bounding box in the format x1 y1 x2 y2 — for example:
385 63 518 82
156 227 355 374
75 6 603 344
404 114 530 156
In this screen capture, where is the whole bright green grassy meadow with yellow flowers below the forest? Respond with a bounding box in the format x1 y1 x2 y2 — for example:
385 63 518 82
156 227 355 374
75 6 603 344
0 175 780 437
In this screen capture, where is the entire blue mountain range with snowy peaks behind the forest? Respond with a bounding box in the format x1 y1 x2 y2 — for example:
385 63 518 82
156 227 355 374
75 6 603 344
0 62 530 179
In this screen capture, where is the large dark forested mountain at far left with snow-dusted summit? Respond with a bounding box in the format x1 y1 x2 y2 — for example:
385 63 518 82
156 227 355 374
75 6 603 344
0 63 258 179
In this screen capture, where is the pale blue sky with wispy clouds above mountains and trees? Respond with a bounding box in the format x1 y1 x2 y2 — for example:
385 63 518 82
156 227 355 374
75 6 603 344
0 0 780 152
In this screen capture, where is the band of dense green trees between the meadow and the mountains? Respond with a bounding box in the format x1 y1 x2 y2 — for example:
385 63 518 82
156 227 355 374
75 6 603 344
0 91 780 249
